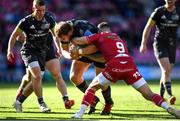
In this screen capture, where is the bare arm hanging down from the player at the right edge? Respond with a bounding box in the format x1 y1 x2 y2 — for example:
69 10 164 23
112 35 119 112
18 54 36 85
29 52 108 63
140 17 156 53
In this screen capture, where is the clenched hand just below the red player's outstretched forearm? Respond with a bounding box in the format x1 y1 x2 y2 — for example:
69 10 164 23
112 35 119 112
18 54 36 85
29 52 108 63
69 45 79 60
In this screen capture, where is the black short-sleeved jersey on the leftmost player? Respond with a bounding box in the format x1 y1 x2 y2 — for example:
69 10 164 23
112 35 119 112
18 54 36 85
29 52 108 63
18 12 55 51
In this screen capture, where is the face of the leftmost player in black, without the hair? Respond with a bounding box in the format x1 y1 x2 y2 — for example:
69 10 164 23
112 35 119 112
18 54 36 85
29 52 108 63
34 5 46 21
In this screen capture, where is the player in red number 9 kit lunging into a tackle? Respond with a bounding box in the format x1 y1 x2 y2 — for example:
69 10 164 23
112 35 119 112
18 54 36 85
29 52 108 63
72 22 180 118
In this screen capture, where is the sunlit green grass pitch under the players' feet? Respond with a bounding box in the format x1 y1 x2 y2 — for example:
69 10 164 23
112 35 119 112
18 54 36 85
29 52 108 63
0 80 180 121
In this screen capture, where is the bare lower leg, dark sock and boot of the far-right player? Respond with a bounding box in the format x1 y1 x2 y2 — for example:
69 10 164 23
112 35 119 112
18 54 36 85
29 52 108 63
157 57 176 104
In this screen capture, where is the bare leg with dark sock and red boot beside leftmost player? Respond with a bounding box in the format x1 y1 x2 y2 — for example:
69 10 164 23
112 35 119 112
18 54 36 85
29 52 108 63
46 58 74 109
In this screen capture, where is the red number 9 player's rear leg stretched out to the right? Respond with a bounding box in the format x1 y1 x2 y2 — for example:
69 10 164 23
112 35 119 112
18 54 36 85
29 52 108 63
132 78 180 118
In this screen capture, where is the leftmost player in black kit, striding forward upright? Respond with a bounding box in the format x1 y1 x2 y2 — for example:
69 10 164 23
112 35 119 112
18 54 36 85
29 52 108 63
7 0 60 112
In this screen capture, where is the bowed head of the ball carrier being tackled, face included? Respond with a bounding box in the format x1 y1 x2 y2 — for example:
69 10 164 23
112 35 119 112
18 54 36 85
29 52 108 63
55 21 73 42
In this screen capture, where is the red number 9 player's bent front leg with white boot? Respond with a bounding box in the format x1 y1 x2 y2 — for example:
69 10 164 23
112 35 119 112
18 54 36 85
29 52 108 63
73 73 110 118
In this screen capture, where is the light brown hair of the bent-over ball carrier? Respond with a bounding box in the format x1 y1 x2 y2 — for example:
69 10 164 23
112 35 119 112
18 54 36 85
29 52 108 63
55 21 73 37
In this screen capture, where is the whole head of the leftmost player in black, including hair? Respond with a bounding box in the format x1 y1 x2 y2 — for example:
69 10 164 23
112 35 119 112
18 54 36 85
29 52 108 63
32 0 46 20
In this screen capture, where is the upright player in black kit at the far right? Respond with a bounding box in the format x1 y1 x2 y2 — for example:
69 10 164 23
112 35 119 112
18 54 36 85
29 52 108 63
140 0 180 104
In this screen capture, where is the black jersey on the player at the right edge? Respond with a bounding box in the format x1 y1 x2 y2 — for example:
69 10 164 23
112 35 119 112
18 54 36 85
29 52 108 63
151 6 180 39
